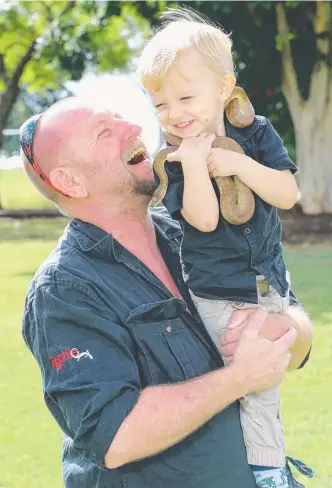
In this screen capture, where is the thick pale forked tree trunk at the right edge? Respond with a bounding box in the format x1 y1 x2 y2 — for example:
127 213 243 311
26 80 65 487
276 1 332 215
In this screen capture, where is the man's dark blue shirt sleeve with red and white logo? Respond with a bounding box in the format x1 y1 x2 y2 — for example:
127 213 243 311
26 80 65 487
23 284 141 468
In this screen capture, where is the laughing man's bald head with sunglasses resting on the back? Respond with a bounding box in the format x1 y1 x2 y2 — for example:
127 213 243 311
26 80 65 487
20 97 154 217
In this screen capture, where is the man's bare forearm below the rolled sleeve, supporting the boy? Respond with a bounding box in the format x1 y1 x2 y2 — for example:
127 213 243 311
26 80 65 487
105 368 244 469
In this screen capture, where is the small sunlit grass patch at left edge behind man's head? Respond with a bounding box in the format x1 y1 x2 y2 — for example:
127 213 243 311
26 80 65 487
0 168 54 210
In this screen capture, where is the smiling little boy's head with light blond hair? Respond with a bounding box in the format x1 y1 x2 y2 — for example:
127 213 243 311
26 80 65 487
138 9 235 138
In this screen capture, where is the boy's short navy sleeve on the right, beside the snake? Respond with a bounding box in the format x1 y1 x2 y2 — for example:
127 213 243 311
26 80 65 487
256 117 298 174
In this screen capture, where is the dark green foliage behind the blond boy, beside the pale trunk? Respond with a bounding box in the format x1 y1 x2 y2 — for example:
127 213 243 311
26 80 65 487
132 1 327 144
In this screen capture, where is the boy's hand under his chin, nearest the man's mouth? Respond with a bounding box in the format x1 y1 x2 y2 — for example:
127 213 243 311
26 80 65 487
167 132 216 169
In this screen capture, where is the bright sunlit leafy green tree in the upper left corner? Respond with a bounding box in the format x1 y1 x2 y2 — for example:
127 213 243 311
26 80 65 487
0 0 148 149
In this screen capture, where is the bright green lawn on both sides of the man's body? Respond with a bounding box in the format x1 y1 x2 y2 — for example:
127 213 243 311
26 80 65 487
0 219 332 488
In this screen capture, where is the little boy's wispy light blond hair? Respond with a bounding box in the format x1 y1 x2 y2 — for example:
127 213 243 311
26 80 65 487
137 8 234 89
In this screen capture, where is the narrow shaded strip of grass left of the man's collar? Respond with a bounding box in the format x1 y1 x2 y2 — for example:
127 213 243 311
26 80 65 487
0 217 68 242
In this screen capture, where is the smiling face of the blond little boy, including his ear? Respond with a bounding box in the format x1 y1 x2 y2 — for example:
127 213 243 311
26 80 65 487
148 48 235 138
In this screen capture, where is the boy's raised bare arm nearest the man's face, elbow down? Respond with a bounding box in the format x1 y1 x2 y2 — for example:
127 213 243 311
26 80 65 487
167 134 219 232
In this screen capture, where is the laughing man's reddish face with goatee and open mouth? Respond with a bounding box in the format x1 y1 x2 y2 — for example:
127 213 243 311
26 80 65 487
76 109 155 200
